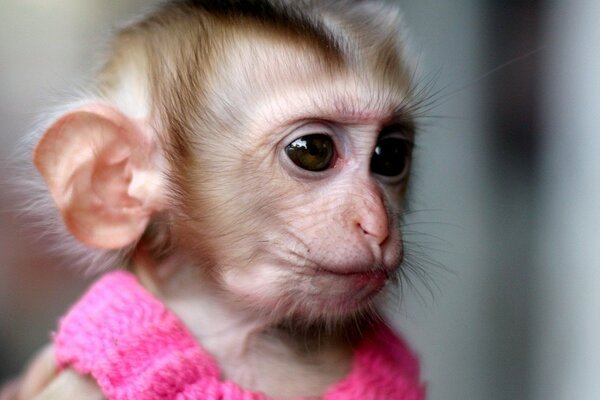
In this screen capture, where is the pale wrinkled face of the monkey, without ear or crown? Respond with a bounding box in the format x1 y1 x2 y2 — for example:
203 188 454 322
176 39 414 319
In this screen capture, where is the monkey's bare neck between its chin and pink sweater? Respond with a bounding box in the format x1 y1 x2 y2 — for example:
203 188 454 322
133 254 353 399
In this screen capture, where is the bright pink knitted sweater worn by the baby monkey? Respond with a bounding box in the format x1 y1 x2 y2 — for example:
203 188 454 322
54 272 425 400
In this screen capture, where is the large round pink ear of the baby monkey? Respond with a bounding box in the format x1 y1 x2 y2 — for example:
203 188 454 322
33 104 162 249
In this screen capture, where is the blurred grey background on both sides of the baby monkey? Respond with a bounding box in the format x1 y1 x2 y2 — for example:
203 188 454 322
0 0 600 400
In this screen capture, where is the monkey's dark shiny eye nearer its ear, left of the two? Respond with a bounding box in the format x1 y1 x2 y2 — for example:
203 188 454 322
285 134 333 171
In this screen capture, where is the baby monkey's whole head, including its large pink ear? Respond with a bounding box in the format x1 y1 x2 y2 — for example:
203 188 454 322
34 1 414 319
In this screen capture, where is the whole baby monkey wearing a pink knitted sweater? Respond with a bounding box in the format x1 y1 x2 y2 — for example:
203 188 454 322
5 0 424 400
